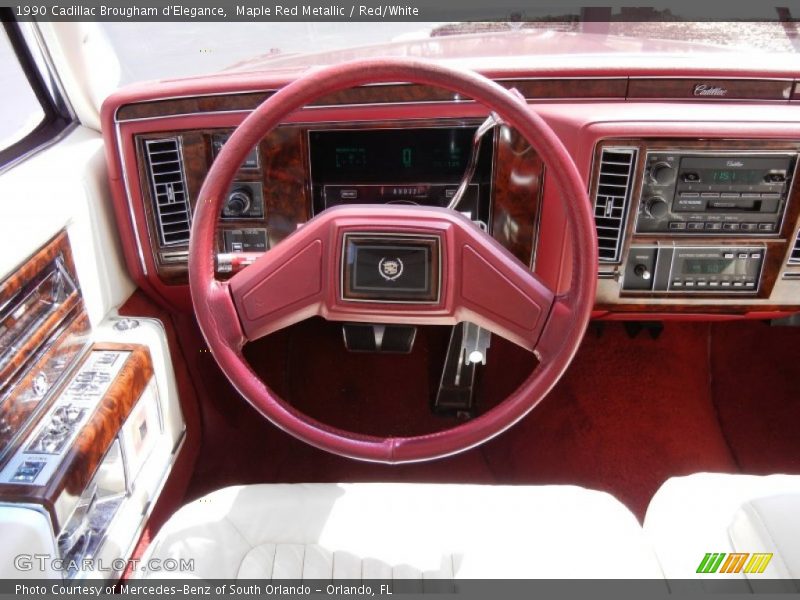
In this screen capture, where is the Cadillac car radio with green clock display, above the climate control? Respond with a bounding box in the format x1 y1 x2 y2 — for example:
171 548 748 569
636 150 797 237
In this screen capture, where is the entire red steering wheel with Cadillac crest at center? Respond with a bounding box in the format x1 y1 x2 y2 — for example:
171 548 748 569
189 59 597 463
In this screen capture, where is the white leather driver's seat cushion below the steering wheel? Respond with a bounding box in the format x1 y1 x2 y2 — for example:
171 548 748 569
144 483 663 580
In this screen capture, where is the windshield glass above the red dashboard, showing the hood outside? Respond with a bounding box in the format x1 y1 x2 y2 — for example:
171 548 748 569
100 20 800 84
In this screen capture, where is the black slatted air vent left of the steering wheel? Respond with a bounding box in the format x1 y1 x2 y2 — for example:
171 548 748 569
145 137 191 246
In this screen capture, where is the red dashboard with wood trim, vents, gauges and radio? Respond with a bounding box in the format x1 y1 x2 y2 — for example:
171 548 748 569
103 66 800 319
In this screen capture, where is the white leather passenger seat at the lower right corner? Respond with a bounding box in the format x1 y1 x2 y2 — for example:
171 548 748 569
644 473 800 591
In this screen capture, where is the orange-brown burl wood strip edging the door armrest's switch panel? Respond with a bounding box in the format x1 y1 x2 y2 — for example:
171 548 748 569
0 343 153 531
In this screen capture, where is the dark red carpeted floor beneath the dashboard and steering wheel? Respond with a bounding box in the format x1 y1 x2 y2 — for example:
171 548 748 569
120 290 800 518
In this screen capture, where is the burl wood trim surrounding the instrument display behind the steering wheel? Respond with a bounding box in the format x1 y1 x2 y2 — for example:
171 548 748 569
135 119 544 286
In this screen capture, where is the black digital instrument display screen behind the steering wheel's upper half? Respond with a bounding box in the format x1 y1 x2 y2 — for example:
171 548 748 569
309 127 478 184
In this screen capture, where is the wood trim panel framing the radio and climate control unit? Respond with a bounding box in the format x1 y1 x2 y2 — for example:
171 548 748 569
590 139 800 314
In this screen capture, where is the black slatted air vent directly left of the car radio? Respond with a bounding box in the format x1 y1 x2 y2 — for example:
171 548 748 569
594 148 636 263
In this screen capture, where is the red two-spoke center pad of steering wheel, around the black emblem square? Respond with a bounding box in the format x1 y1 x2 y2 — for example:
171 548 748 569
229 205 554 350
